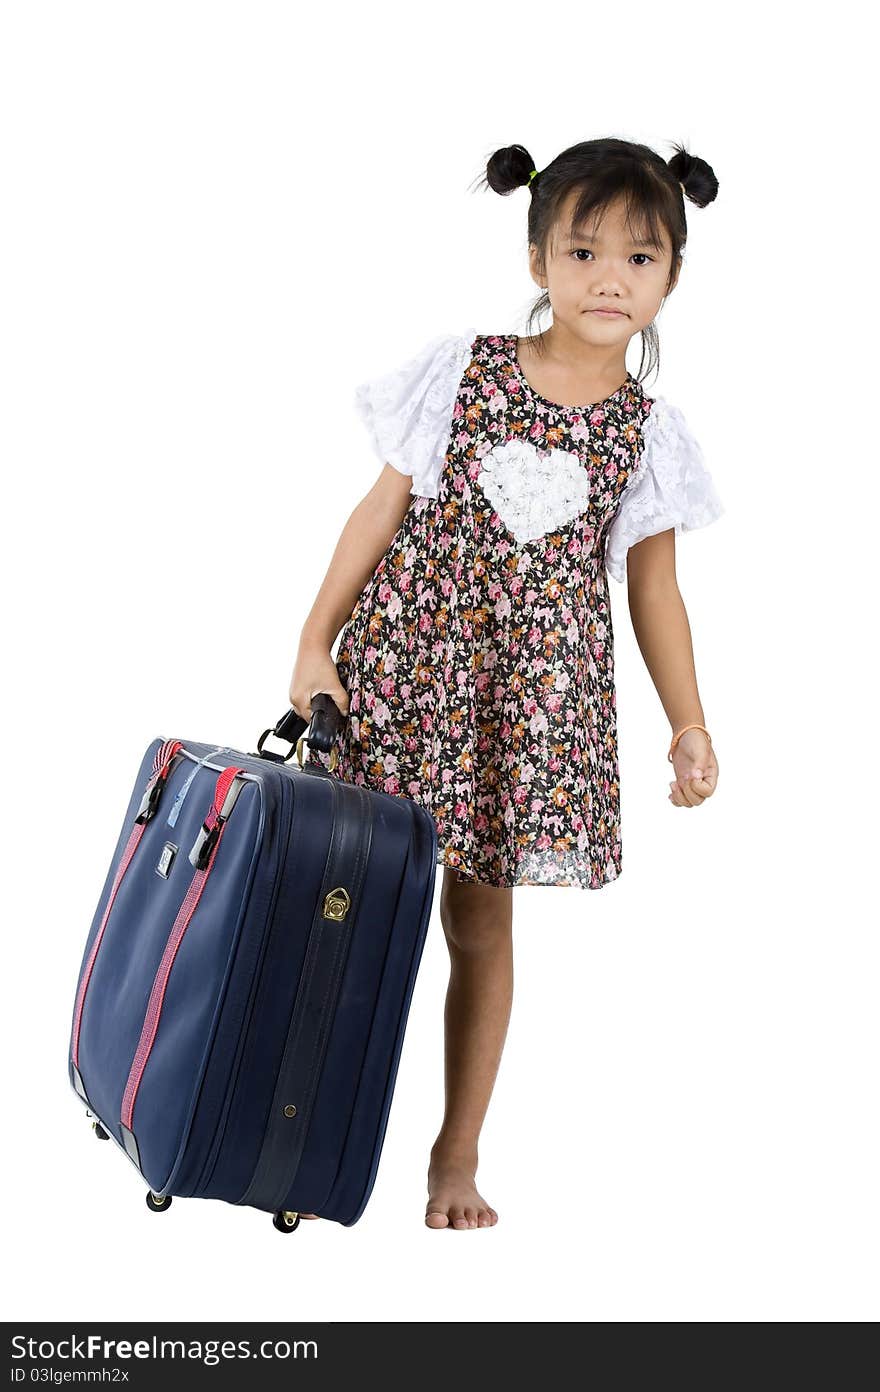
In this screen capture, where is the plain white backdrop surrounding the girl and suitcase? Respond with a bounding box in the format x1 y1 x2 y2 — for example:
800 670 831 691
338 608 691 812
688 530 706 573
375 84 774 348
0 0 880 1321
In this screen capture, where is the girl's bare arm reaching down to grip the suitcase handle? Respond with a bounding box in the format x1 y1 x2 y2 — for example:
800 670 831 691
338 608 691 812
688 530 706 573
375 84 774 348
290 464 412 720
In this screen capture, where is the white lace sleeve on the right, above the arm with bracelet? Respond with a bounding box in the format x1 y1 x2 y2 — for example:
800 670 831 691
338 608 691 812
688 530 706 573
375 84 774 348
606 397 724 582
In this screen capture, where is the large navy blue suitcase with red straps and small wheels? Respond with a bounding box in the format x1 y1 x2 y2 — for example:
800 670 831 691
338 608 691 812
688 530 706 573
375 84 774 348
68 693 437 1232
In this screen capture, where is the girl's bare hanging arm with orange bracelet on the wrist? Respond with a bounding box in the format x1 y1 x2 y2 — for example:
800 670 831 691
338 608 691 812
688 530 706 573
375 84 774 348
627 528 718 807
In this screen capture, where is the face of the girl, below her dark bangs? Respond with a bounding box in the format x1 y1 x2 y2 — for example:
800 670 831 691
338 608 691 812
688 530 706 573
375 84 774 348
529 192 681 348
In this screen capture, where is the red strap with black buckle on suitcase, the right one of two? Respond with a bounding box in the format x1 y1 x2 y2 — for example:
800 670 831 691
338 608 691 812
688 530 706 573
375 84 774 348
121 766 246 1146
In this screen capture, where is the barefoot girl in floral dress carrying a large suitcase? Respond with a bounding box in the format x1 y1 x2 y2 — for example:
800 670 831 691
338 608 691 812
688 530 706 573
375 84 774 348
290 139 723 1229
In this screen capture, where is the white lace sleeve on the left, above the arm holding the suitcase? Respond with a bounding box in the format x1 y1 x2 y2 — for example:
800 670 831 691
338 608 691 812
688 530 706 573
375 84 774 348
355 329 476 498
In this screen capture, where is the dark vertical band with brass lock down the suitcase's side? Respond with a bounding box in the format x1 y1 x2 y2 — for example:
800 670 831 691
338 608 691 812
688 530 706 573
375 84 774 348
238 780 373 1211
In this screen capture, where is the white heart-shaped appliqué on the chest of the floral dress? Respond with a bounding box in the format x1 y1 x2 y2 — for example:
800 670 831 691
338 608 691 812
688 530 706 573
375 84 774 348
476 440 590 544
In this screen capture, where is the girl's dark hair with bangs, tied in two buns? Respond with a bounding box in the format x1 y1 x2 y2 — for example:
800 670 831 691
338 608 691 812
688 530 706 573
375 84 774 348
482 138 718 381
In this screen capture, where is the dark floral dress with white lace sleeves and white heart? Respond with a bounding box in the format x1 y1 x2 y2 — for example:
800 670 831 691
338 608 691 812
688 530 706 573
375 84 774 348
306 330 724 889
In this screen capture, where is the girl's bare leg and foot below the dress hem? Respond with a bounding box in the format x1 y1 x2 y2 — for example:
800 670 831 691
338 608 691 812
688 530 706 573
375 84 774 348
425 866 514 1229
